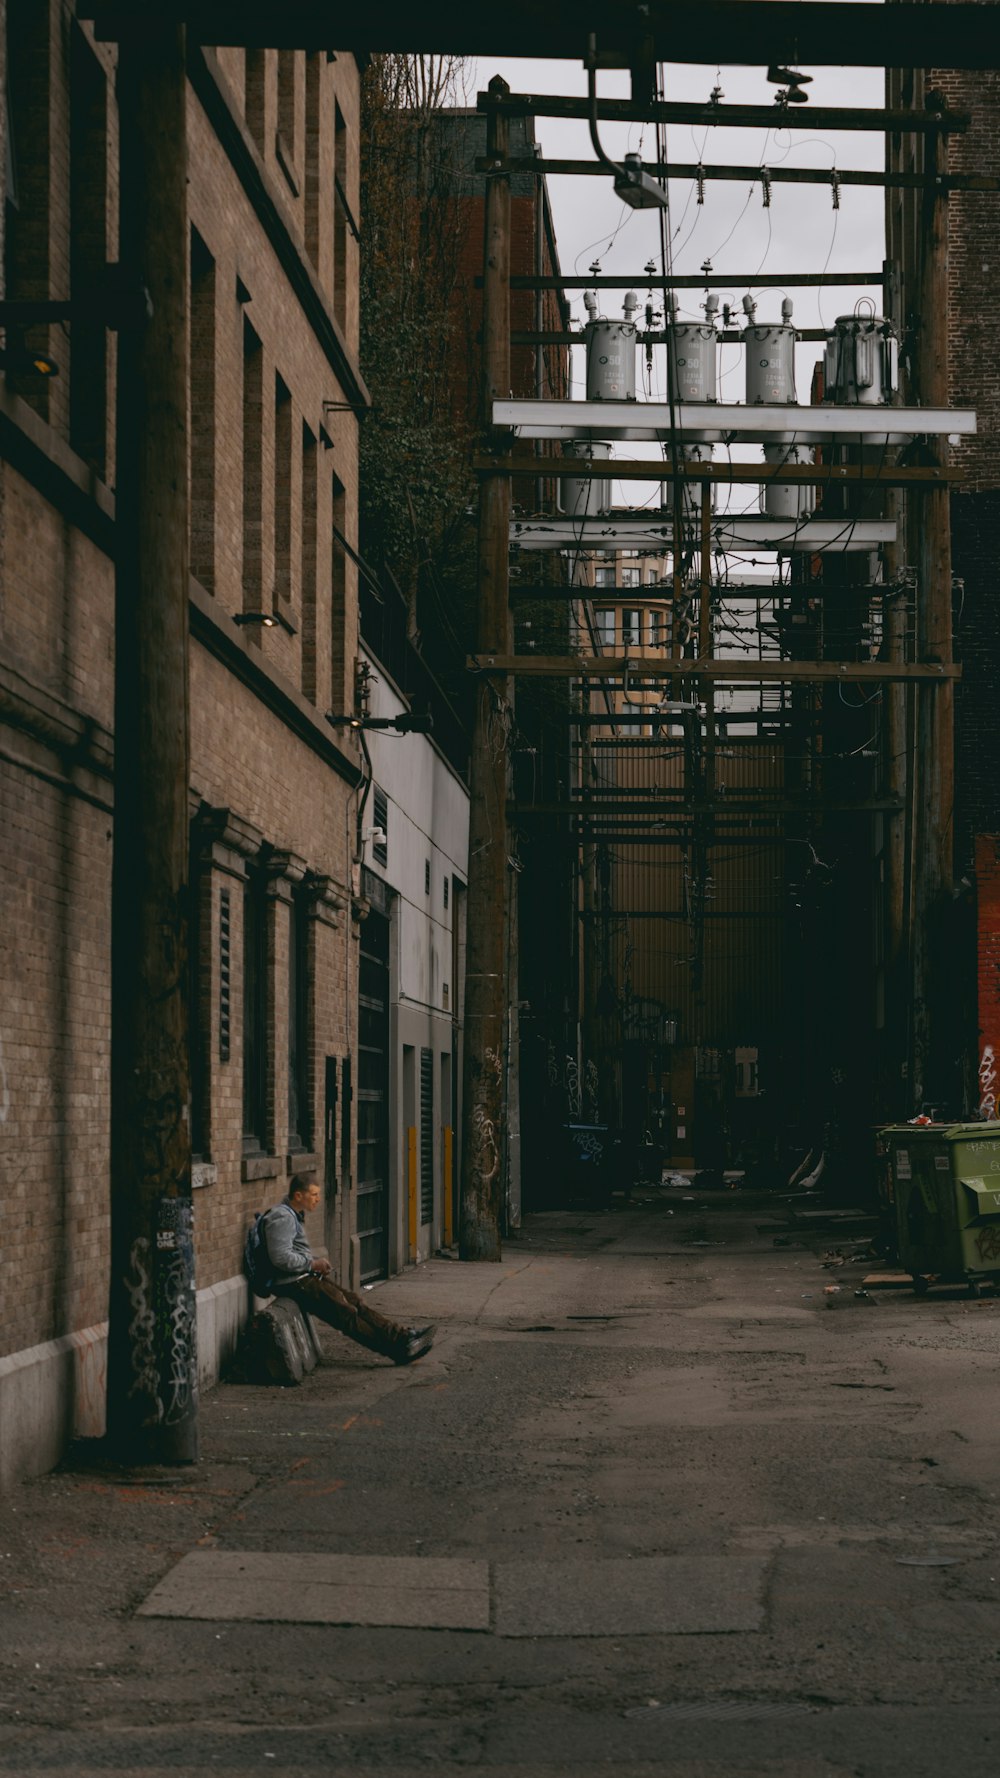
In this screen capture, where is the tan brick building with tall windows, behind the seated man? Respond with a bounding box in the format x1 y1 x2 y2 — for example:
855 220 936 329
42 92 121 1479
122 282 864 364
0 0 367 1476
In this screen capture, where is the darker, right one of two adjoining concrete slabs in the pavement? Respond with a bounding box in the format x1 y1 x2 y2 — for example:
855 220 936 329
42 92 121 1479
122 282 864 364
496 1556 767 1636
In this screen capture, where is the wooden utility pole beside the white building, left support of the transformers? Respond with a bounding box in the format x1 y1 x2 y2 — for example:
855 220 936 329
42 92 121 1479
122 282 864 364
459 75 511 1259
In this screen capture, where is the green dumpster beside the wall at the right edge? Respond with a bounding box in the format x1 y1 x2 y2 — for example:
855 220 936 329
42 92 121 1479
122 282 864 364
883 1124 1000 1296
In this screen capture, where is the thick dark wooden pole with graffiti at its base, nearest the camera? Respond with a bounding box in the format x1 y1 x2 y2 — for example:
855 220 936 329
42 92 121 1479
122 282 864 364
109 16 198 1463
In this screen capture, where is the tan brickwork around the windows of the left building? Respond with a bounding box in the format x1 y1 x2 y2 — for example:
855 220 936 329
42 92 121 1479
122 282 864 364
0 38 366 1386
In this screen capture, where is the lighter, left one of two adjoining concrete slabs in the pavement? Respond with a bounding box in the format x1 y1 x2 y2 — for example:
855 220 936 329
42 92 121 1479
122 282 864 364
139 1550 489 1630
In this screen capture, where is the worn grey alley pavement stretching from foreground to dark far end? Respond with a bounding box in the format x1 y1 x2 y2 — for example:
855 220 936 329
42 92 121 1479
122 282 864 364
0 1181 1000 1778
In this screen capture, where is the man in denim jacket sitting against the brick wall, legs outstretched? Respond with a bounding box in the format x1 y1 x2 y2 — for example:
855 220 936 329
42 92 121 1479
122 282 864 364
260 1173 434 1364
